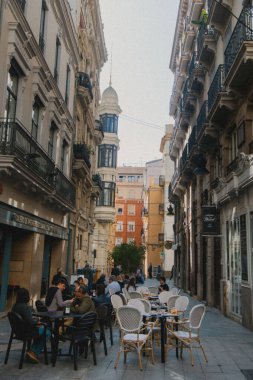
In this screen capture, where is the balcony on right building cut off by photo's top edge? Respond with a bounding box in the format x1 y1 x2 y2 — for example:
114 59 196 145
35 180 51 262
208 0 233 32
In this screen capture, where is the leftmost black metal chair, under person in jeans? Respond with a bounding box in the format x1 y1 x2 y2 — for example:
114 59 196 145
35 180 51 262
4 311 48 369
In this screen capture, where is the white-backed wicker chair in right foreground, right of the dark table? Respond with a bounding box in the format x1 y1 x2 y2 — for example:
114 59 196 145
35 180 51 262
168 304 207 366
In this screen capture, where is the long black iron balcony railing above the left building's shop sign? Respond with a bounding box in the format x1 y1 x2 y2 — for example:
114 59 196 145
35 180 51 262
0 120 75 207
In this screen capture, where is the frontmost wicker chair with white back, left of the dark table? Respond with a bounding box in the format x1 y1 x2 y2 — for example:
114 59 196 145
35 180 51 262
114 306 154 370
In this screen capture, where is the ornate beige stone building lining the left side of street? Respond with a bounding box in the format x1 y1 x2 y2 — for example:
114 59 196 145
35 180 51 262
0 0 106 310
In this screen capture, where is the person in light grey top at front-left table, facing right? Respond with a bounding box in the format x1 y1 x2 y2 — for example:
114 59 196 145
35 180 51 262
45 279 74 311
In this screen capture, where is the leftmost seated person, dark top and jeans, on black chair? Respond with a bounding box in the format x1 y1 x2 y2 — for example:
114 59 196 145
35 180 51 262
11 288 50 363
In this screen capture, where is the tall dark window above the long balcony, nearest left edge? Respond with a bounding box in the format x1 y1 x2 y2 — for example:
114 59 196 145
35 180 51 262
4 67 18 119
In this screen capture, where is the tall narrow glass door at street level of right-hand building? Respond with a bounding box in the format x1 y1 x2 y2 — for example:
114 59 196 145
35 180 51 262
229 218 242 316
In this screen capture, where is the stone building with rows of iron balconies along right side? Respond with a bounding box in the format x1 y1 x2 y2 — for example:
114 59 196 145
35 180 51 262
170 0 253 328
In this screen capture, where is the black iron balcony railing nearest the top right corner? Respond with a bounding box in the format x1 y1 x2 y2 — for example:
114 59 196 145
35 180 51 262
224 7 253 76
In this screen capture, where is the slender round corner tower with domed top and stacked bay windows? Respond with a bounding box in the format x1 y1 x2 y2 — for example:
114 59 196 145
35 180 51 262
93 85 121 273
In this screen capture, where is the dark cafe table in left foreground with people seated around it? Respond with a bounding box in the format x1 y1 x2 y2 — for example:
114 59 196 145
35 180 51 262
33 311 83 366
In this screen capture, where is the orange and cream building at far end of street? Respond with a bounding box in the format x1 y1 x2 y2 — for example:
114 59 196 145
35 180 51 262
115 166 144 246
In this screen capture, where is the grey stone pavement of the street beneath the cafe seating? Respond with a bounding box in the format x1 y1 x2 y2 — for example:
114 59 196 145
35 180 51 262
0 280 253 380
